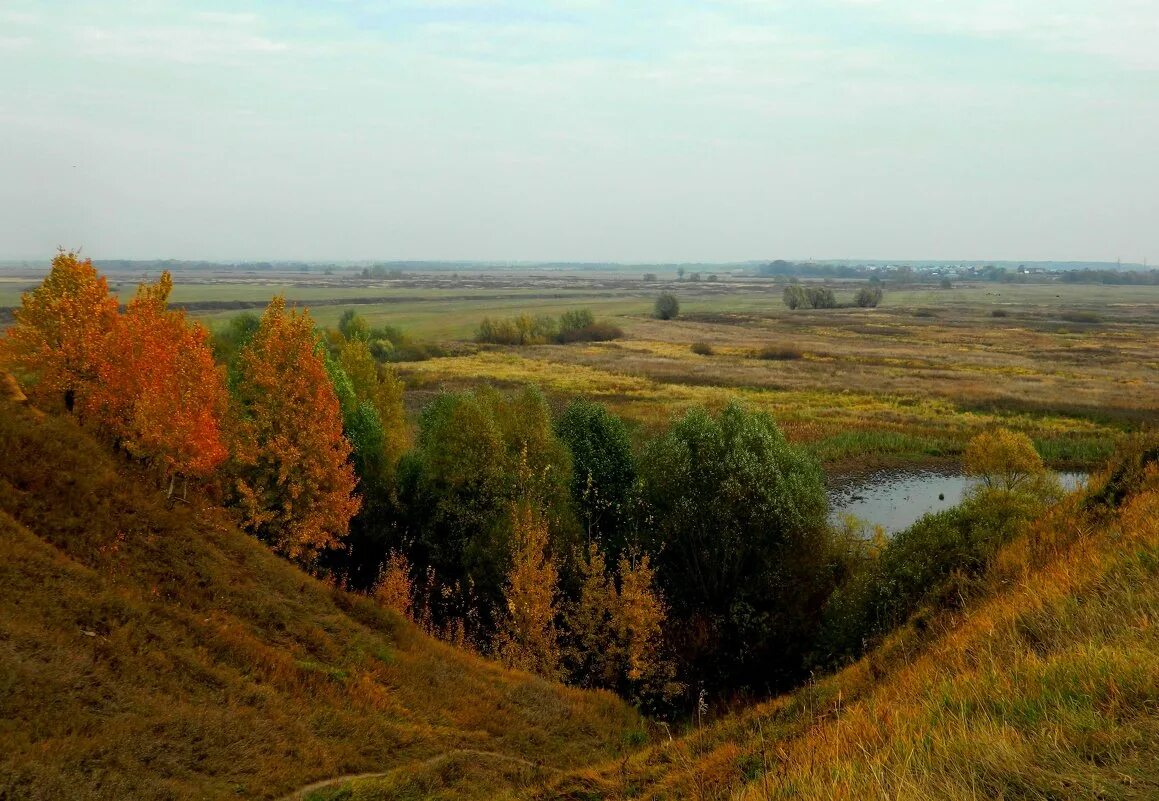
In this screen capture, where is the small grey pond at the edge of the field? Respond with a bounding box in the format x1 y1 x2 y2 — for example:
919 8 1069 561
829 471 1087 533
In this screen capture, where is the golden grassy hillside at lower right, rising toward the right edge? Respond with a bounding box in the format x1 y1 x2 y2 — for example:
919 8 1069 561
540 454 1159 801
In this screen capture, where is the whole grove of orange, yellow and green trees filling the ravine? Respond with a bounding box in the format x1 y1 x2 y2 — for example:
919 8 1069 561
0 252 1058 709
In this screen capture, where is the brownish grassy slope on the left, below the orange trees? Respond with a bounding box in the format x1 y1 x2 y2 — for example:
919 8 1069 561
0 395 640 799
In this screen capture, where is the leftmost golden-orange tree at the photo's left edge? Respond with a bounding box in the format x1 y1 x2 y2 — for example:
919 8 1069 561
0 250 117 410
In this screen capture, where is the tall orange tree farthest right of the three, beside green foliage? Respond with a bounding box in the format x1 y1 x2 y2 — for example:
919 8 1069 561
232 297 360 563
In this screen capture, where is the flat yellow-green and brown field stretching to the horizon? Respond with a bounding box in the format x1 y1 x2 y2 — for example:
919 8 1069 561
0 270 1159 472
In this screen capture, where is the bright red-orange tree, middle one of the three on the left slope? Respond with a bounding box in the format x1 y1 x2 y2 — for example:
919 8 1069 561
83 272 228 493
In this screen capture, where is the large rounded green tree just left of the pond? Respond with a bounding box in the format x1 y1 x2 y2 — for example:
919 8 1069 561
640 403 829 686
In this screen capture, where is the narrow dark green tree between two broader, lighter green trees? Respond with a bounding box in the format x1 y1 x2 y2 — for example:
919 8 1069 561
555 399 636 562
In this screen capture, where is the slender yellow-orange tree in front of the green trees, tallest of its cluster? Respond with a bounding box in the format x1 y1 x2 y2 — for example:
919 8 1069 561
496 503 560 678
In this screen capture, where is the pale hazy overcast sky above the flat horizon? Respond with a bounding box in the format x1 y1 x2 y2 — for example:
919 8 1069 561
0 0 1159 263
